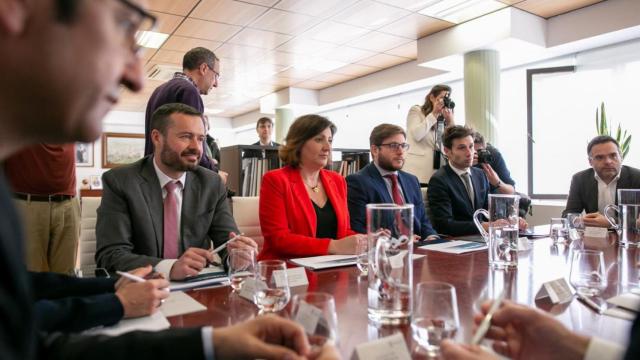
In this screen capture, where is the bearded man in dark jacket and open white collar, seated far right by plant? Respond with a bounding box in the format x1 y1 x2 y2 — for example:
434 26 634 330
562 135 640 227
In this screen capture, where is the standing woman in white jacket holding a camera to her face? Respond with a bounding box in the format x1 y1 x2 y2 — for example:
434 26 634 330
404 85 455 186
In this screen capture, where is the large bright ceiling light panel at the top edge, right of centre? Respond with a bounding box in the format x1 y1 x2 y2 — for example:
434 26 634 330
418 0 507 24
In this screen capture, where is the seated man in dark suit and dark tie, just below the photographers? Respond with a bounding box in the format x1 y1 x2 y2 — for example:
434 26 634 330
427 125 490 236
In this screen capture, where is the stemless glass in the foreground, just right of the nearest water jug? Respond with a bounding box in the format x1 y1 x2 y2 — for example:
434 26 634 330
411 281 460 357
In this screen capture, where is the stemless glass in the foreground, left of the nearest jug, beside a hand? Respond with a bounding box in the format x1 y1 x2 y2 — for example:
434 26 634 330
291 292 338 352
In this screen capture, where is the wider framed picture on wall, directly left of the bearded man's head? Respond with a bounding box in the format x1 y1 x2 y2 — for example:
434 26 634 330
102 133 144 168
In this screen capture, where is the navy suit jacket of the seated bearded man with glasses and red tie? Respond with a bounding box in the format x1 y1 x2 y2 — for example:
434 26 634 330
347 163 436 239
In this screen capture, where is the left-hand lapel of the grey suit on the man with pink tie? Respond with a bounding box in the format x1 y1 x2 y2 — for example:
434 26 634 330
140 156 164 257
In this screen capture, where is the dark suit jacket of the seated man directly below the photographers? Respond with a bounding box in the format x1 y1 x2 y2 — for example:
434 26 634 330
427 165 489 236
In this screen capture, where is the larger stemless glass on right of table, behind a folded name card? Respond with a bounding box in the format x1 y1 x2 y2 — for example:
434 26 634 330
570 250 607 296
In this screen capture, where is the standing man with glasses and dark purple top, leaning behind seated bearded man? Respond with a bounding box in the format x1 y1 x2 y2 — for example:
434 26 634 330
144 47 227 179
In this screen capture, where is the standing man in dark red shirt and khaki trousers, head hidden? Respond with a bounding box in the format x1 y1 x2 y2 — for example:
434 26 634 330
5 144 80 274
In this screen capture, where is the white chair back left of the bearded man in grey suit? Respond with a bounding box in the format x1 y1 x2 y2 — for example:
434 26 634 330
76 197 102 274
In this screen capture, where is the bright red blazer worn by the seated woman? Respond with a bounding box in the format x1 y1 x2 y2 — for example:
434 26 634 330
258 166 356 260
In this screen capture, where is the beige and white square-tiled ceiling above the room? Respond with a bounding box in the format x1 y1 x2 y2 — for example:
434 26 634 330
116 0 601 117
